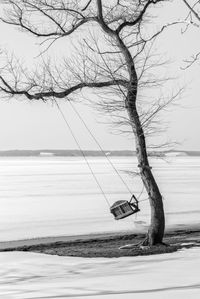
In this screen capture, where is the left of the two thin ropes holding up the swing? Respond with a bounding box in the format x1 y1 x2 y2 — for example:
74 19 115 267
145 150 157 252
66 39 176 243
54 98 110 208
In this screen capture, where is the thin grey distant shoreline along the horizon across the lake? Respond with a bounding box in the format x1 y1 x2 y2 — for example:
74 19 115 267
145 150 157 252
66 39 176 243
0 149 200 157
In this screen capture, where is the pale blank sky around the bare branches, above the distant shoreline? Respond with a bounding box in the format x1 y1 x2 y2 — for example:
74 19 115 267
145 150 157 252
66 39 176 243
0 1 200 150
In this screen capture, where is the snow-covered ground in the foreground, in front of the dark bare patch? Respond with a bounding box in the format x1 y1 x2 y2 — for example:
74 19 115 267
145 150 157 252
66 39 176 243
0 248 200 299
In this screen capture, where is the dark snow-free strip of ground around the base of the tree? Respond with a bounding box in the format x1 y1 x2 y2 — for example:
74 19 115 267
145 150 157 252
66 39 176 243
0 228 200 257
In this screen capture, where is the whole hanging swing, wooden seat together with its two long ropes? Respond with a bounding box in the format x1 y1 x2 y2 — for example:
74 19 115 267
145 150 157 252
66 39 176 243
54 99 140 220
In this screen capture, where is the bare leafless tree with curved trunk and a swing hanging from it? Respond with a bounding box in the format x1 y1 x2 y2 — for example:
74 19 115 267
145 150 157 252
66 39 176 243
0 0 176 245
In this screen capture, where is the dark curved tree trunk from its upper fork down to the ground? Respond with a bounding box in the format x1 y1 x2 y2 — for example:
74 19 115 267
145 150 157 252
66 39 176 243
116 35 165 246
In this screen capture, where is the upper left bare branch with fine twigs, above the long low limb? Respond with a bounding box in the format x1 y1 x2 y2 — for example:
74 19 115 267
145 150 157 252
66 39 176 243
0 0 96 38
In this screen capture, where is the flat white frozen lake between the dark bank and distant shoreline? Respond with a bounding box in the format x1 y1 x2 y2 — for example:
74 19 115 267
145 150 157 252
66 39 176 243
0 157 200 241
